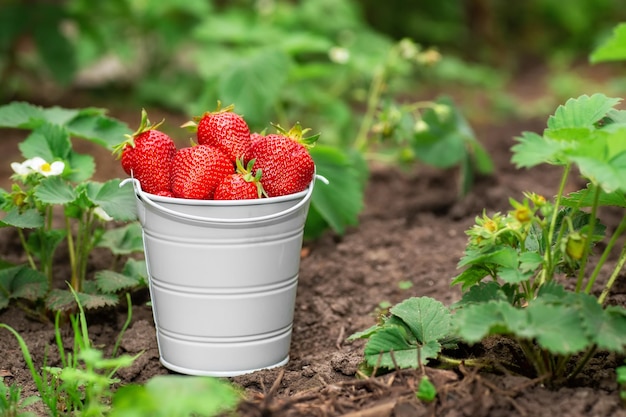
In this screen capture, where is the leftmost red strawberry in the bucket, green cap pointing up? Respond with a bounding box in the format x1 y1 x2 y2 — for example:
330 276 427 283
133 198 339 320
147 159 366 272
113 110 176 195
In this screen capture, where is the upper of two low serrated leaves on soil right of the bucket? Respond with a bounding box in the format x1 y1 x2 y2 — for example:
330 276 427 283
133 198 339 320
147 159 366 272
390 297 451 344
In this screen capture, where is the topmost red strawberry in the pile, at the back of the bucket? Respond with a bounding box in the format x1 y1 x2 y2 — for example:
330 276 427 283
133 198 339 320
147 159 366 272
183 102 250 163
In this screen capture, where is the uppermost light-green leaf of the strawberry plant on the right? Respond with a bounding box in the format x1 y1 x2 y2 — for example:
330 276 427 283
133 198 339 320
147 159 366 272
548 94 621 129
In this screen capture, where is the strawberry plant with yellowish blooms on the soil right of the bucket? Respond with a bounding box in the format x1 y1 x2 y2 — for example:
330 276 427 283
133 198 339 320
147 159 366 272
356 94 626 386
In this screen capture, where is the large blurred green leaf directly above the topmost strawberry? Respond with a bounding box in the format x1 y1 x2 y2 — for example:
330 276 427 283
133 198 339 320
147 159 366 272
217 48 291 125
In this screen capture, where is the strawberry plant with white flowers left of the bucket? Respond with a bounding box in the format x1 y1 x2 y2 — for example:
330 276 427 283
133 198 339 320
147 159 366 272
0 102 147 317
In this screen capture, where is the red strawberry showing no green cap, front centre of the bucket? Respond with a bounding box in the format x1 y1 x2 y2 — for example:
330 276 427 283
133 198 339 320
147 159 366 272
172 145 234 200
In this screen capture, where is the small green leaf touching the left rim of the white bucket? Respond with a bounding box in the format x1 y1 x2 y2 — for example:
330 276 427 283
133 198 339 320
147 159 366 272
87 179 137 221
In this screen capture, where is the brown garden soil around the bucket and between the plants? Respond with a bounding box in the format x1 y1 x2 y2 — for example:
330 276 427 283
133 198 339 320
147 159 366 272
0 105 626 417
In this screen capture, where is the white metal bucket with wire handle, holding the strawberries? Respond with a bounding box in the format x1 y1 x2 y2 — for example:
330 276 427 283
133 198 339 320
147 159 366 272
121 179 315 377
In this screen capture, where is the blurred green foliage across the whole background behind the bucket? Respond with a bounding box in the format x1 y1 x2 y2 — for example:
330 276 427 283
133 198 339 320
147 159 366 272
0 0 626 239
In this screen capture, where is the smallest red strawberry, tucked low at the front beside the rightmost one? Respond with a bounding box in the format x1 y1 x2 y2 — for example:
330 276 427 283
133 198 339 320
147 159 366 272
213 159 264 200
